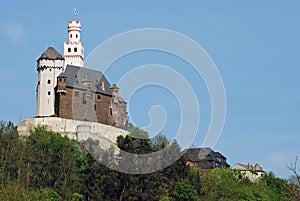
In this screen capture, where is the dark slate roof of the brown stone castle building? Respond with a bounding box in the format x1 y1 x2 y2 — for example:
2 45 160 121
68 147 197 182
61 65 112 96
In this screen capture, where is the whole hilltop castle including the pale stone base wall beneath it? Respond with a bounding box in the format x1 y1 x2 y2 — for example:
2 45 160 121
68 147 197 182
17 20 128 143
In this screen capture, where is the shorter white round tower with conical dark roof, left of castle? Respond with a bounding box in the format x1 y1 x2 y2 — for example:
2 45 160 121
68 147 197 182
36 47 64 117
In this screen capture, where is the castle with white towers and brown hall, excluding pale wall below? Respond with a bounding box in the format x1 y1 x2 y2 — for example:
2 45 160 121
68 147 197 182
36 20 128 129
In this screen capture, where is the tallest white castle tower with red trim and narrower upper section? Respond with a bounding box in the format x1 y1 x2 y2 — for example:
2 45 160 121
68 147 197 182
64 20 84 67
